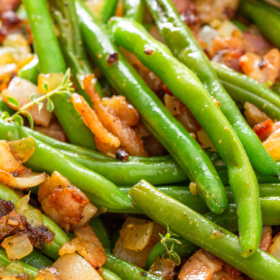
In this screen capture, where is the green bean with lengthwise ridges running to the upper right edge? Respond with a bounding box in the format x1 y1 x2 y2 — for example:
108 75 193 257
212 63 280 120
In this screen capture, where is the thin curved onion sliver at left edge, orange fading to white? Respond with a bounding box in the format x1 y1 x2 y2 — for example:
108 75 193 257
0 169 47 189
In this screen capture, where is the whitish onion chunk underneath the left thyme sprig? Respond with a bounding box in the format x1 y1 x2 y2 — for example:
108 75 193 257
1 77 52 126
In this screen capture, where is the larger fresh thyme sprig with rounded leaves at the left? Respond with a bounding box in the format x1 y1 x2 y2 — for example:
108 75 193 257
1 68 73 128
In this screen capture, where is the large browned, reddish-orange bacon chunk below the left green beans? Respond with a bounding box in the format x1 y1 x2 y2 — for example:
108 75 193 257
38 171 97 232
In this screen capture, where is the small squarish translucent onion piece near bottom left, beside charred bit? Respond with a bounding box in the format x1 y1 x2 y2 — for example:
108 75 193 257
1 232 33 261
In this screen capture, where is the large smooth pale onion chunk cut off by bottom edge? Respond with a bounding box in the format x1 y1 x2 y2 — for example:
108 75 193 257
53 253 103 280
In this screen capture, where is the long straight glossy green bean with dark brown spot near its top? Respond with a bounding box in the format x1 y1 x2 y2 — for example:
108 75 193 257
75 0 227 213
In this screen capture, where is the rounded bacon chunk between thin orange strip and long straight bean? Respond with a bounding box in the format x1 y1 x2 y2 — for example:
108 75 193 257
102 95 140 126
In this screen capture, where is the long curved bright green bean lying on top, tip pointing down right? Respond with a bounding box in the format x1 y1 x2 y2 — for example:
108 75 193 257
110 18 262 258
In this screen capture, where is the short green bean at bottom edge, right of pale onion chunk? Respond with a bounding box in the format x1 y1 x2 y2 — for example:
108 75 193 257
104 253 161 280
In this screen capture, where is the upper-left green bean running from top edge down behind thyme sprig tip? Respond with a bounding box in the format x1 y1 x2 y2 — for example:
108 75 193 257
23 0 95 149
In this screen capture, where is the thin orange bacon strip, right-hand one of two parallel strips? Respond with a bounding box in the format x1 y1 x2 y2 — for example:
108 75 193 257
83 75 149 157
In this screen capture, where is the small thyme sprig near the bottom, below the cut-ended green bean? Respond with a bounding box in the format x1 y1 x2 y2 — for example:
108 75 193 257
159 226 182 266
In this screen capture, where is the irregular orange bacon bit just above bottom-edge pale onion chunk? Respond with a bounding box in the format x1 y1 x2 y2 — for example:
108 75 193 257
59 225 107 272
